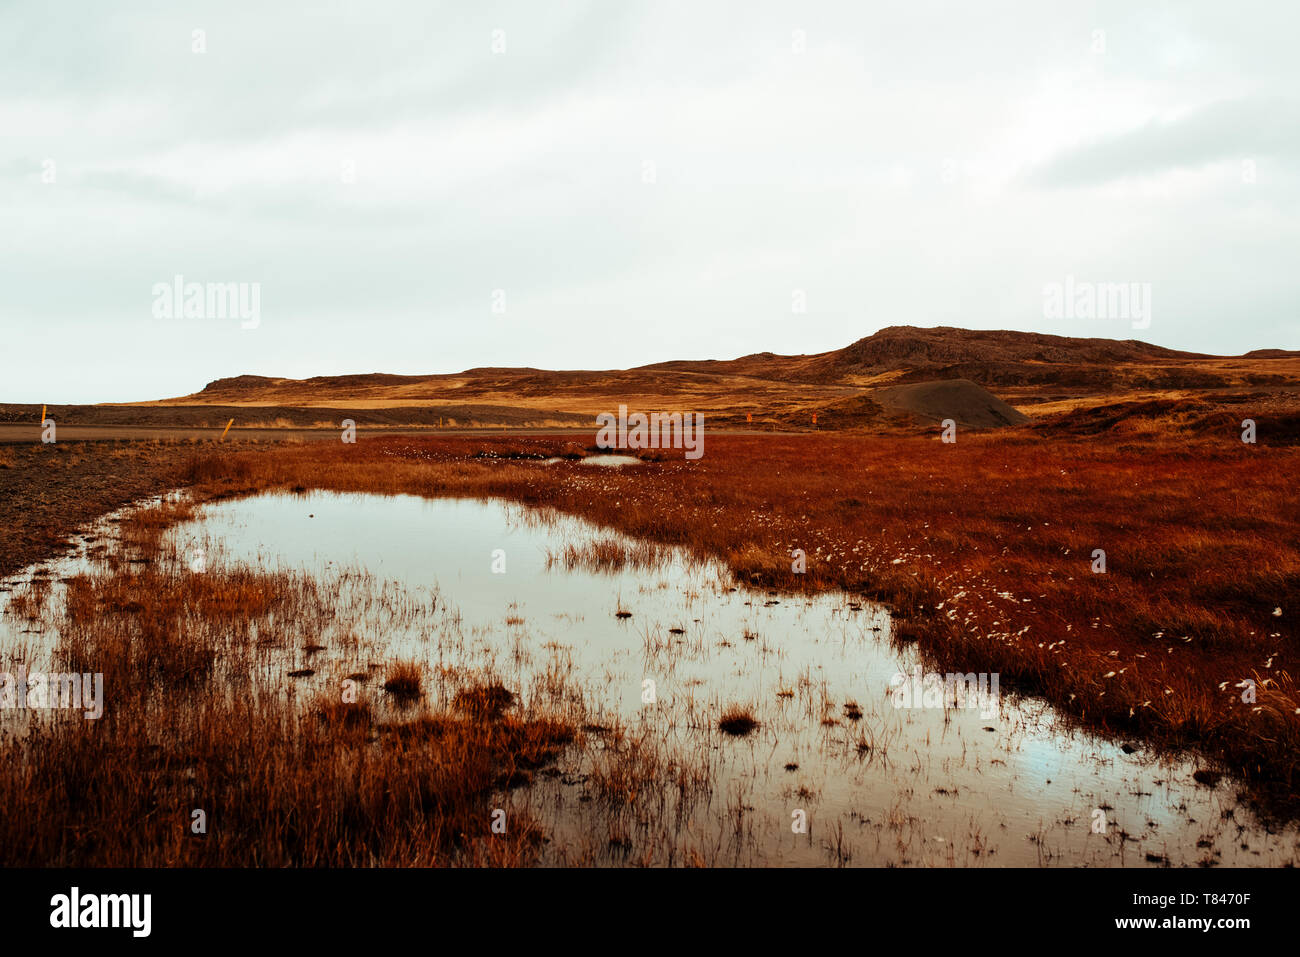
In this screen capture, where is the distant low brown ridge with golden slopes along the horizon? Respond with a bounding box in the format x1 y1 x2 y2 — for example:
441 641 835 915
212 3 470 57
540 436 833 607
104 325 1300 429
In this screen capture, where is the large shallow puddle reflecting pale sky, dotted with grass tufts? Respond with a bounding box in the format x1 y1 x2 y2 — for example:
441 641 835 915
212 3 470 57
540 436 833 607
0 494 1300 866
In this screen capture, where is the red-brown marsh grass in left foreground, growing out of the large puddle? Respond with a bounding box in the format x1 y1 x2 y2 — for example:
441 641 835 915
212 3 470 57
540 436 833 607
0 509 590 866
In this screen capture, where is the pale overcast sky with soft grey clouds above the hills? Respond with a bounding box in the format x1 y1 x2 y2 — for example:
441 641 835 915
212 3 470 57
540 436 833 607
0 0 1300 403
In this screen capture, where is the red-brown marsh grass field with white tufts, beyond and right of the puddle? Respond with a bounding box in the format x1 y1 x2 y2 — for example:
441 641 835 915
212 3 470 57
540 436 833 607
180 428 1300 805
